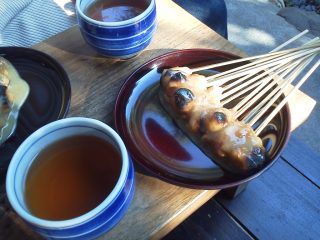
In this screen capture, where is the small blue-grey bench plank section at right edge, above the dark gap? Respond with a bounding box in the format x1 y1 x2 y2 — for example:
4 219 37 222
282 136 320 187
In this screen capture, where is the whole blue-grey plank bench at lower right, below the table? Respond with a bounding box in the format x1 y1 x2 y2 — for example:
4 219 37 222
165 137 320 240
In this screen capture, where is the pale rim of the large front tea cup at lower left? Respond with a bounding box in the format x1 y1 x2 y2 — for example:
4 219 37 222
6 117 129 229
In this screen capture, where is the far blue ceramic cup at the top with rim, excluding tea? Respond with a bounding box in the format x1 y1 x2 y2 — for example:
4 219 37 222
76 0 156 59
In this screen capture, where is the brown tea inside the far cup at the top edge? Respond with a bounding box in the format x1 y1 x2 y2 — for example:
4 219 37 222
84 0 149 22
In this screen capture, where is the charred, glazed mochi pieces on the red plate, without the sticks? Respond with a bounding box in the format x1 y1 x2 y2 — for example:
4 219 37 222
159 67 265 174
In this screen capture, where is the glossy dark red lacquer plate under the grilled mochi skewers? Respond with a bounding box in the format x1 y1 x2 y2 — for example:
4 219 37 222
115 49 290 189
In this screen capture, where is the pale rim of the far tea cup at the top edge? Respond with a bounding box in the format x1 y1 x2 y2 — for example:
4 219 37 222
76 0 155 27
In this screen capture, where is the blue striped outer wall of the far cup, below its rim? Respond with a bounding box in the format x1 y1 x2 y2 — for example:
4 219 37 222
77 0 156 58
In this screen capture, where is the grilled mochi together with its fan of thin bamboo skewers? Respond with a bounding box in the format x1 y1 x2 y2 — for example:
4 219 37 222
159 31 320 174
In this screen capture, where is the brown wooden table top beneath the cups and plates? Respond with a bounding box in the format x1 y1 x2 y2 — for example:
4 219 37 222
0 0 315 239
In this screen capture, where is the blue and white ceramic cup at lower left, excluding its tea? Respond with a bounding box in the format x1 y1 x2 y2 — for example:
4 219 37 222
6 117 135 239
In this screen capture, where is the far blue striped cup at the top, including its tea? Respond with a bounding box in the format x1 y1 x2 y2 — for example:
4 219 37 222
76 0 156 59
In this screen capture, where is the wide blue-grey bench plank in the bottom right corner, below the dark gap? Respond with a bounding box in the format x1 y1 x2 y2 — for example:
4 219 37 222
216 159 320 239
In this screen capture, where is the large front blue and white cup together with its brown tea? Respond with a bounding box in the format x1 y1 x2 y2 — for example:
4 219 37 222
6 118 134 239
